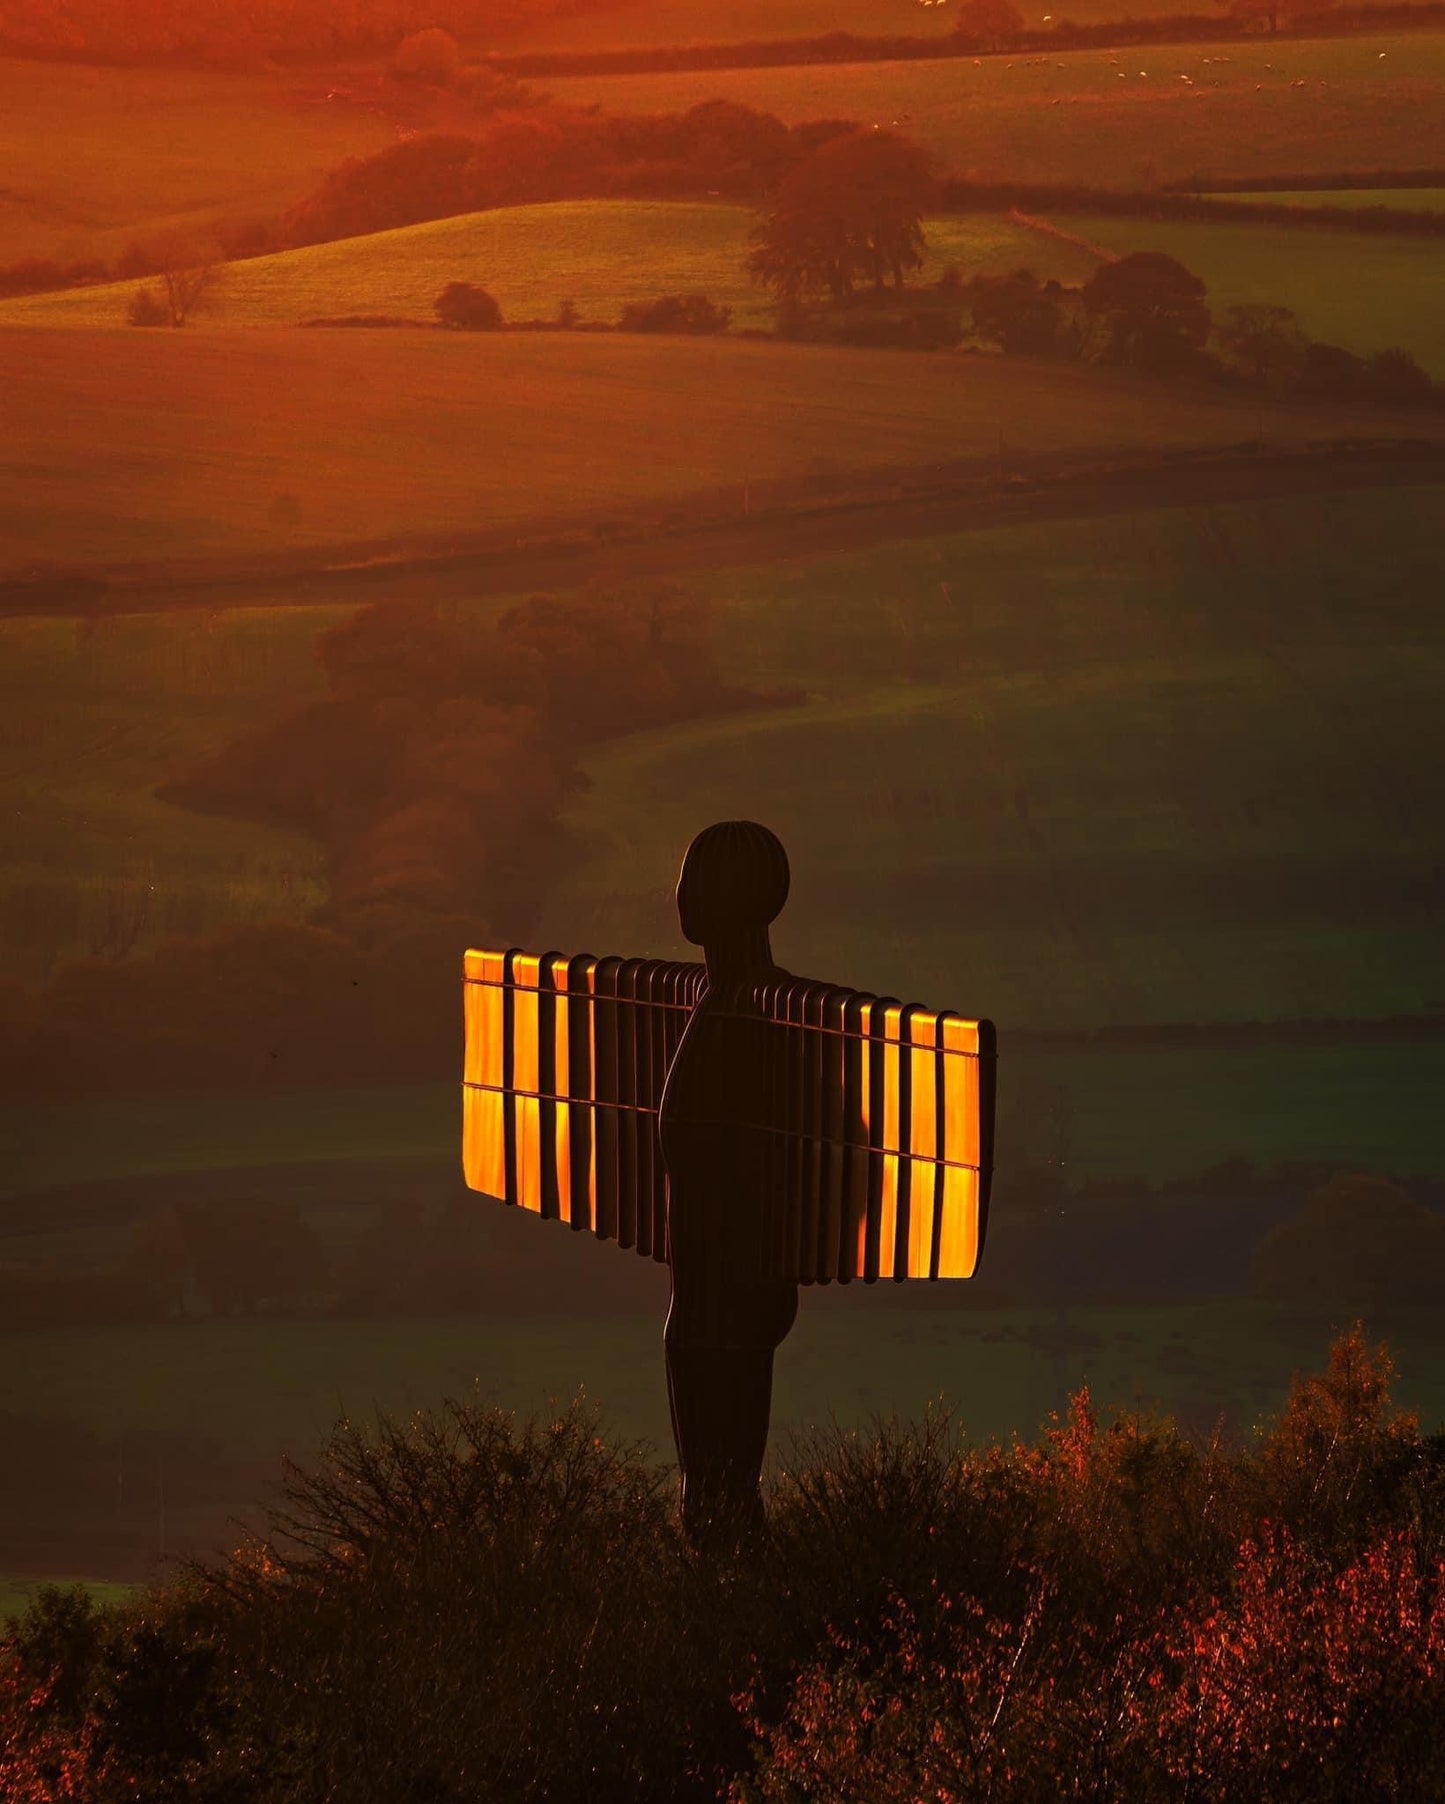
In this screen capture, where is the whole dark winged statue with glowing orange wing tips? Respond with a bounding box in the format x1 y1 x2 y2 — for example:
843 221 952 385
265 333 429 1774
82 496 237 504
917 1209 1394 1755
462 821 994 1546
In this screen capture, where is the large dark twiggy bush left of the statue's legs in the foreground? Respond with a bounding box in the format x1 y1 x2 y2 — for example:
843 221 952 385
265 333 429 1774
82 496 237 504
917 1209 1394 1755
195 1404 731 1804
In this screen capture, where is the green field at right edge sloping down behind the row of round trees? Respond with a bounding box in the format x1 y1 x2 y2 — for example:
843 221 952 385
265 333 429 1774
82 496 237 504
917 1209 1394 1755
1057 215 1445 377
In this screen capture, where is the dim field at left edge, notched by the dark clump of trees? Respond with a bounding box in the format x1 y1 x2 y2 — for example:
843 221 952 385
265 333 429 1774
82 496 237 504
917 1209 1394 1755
0 608 327 976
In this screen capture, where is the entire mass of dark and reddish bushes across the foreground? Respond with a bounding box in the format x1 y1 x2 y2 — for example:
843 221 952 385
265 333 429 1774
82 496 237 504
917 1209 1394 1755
0 1330 1445 1804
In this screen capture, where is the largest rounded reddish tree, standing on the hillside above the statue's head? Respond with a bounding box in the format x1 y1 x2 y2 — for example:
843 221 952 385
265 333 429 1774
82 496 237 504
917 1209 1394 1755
749 130 931 303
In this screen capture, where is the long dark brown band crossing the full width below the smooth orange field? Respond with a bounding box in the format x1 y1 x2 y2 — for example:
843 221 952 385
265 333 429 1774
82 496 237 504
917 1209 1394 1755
0 438 1445 619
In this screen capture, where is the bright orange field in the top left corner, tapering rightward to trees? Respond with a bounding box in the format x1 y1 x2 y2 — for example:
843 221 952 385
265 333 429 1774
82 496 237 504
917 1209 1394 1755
0 58 395 263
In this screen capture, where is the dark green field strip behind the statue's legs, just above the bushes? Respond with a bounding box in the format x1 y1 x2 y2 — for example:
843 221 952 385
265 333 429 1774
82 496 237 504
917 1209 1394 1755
0 1306 1445 1472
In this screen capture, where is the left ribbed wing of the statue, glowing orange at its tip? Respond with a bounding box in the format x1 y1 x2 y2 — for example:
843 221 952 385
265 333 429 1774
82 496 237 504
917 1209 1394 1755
462 951 704 1261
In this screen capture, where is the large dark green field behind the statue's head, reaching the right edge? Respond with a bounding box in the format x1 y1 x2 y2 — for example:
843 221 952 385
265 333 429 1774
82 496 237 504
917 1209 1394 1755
539 489 1445 1026
